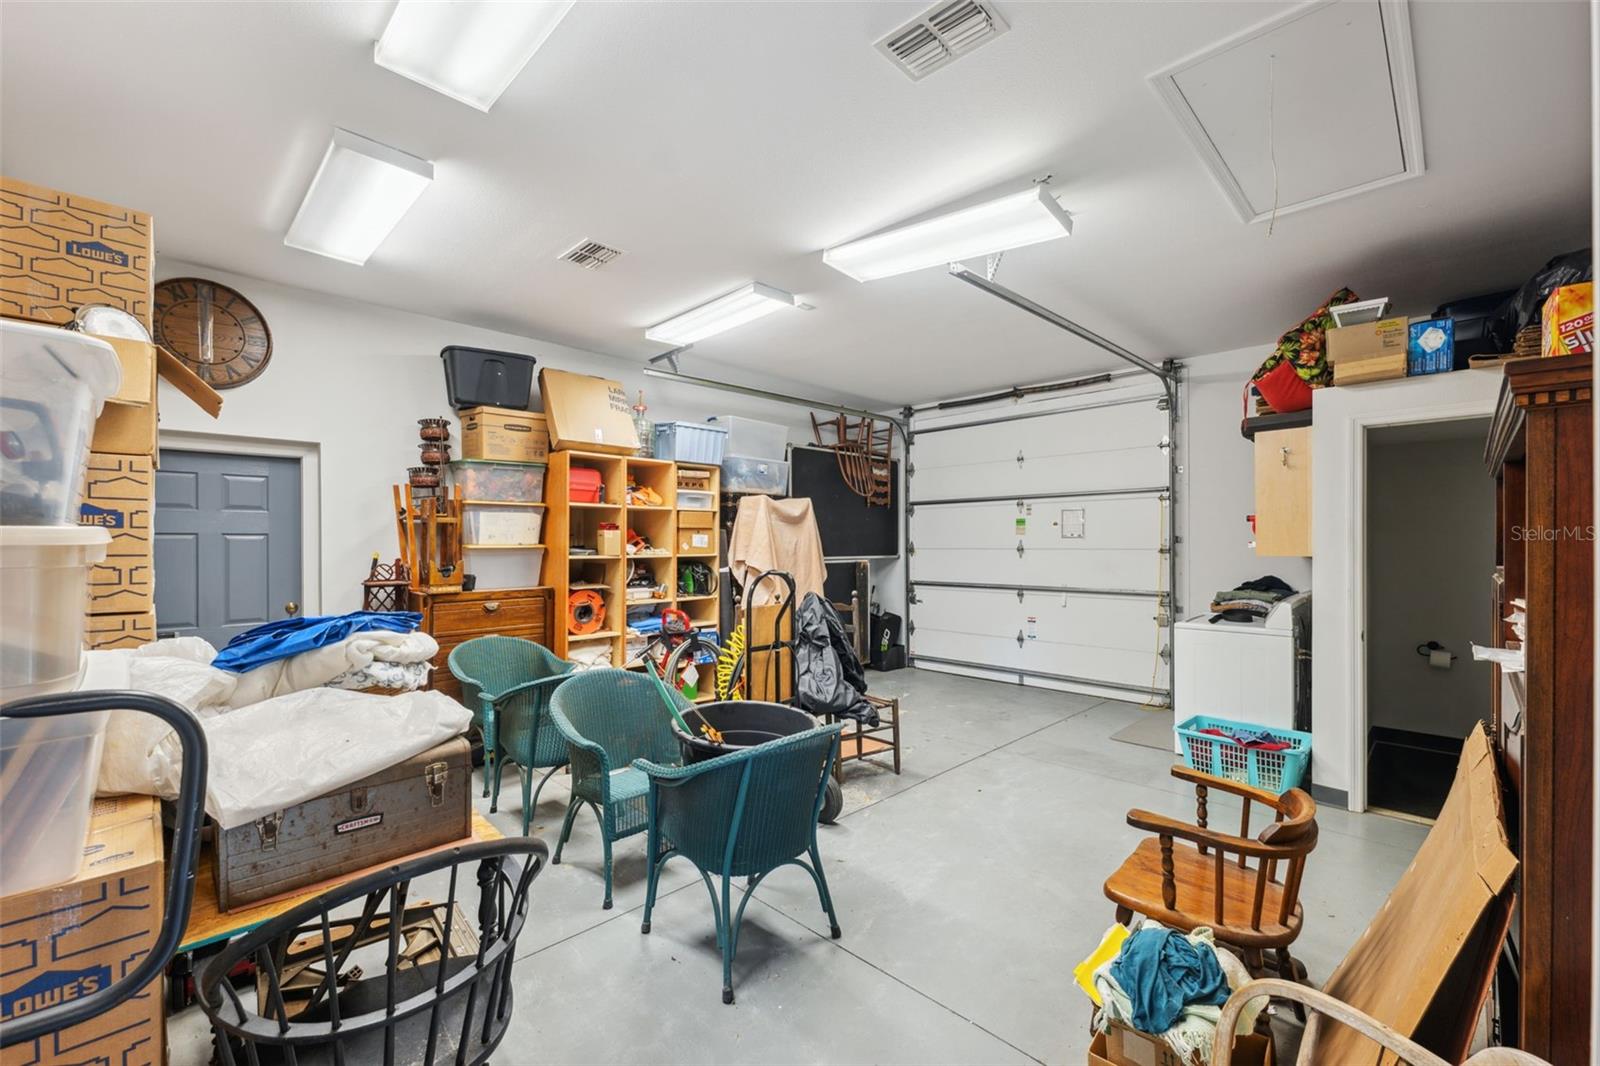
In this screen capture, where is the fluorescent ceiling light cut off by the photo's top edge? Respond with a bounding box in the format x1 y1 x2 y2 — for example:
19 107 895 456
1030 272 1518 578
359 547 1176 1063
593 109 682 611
373 0 578 110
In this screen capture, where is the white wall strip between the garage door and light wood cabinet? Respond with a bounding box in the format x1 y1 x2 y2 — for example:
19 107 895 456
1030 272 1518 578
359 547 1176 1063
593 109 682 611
1178 344 1310 616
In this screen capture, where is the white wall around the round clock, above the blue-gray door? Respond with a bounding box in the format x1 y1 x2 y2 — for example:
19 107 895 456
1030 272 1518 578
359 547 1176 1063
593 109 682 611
157 259 832 613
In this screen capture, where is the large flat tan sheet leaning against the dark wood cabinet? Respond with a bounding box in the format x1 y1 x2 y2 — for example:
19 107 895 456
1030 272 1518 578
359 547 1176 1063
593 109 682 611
1304 723 1517 1066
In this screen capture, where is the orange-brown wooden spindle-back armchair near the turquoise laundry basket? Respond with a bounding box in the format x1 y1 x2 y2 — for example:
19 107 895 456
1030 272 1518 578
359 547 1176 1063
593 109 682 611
1106 765 1317 1007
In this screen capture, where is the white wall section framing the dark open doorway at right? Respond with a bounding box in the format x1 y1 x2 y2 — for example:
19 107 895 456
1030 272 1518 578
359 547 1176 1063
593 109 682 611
1312 370 1502 810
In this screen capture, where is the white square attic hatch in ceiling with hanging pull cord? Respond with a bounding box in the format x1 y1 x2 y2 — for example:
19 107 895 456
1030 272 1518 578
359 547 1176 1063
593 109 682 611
1150 0 1422 222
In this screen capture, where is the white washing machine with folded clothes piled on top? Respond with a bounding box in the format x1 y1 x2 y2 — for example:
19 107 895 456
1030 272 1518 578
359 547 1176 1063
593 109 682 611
1173 592 1310 754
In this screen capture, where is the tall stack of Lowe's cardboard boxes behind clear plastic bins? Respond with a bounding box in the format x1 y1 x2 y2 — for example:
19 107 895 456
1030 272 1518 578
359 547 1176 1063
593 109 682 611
0 178 222 648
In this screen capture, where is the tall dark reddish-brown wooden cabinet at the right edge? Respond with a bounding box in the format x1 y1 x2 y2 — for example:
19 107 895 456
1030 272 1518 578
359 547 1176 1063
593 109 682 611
1485 355 1595 1063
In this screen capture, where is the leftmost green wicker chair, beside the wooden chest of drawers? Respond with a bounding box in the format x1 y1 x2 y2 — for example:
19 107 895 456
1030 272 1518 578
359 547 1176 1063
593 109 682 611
450 637 573 836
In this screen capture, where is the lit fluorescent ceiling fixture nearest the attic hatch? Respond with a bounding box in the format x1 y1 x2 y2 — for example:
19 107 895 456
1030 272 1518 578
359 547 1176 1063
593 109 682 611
822 186 1072 282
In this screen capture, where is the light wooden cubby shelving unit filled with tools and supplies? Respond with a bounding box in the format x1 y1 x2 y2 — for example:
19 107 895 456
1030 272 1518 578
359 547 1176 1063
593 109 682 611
544 451 722 666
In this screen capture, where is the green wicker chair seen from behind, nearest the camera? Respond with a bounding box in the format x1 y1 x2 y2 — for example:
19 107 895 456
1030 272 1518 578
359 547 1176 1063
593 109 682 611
634 723 845 1004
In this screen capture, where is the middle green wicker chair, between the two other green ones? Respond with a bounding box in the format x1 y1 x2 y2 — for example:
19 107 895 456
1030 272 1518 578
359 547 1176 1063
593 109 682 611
550 669 693 909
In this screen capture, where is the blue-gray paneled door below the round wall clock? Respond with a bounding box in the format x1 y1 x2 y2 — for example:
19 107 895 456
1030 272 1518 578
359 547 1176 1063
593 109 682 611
155 448 301 648
